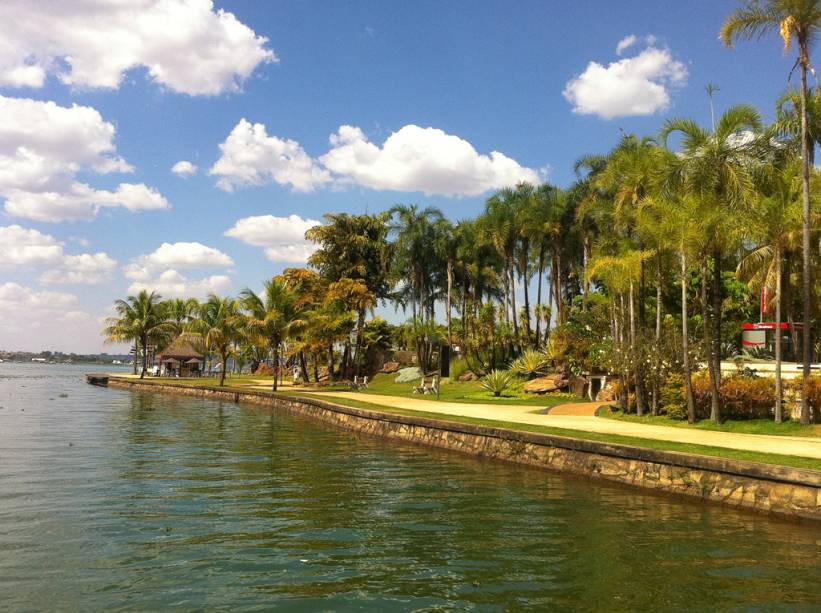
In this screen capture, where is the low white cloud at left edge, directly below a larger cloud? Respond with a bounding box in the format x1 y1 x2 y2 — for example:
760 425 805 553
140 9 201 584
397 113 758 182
0 225 117 284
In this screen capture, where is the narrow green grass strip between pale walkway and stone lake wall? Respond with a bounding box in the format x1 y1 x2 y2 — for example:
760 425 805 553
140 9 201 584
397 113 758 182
286 392 821 470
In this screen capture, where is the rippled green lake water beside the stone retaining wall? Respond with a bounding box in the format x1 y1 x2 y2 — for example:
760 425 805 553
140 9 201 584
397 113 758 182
0 364 821 611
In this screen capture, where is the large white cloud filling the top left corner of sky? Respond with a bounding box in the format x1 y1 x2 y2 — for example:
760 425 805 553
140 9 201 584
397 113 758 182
0 0 277 95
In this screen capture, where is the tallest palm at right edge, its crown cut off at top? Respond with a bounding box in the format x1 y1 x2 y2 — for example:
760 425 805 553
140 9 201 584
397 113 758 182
721 0 821 424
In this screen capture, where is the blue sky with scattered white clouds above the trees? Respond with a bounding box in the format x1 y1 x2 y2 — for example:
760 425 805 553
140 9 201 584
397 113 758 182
0 0 792 351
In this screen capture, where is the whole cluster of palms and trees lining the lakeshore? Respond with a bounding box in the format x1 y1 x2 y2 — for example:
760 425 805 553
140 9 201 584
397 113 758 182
106 0 821 423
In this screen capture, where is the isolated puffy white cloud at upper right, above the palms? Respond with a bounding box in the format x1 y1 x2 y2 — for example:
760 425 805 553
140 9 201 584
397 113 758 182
563 44 687 119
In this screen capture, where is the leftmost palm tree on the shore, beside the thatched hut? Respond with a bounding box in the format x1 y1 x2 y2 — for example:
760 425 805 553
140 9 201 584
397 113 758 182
103 290 174 379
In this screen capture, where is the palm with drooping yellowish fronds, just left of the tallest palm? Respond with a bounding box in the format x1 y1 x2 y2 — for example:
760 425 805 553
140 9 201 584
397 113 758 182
737 158 801 423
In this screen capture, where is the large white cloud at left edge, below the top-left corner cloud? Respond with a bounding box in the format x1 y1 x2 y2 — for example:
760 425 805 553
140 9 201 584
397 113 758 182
0 96 169 221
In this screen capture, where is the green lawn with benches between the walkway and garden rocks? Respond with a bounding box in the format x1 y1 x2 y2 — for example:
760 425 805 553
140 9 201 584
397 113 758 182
350 374 587 407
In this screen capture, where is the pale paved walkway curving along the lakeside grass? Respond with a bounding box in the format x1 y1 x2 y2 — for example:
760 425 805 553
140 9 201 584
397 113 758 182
298 390 821 459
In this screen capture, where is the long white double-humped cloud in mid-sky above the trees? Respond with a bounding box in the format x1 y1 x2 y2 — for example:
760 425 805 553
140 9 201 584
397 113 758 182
209 119 542 196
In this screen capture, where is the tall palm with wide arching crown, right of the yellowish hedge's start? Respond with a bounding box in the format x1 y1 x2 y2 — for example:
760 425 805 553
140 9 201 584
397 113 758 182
660 105 762 423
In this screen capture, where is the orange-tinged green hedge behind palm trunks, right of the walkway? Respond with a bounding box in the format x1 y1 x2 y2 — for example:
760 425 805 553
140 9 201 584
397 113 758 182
693 373 775 419
